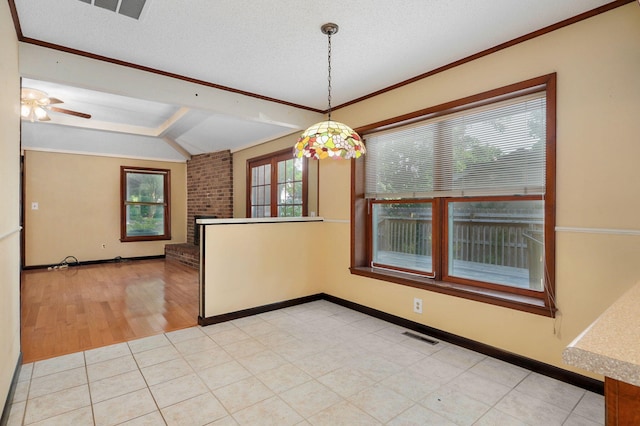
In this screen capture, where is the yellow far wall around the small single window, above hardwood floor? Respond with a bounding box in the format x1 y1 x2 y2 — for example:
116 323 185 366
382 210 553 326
25 151 187 266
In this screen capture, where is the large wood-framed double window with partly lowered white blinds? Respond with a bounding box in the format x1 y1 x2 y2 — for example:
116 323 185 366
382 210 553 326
351 74 555 316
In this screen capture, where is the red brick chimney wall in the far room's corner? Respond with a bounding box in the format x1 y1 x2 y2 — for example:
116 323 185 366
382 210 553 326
187 150 233 243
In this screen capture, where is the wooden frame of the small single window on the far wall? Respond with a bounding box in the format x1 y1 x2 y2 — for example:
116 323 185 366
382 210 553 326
120 166 171 243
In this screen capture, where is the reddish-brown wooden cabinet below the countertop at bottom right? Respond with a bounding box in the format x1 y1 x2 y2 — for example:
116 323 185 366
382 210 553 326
604 377 640 426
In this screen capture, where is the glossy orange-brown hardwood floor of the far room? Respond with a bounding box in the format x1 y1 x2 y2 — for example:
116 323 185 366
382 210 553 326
21 259 198 363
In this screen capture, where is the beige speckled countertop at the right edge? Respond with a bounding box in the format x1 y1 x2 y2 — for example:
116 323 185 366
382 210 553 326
562 283 640 386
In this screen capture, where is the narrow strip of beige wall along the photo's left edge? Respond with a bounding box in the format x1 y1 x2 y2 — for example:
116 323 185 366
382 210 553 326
0 1 20 407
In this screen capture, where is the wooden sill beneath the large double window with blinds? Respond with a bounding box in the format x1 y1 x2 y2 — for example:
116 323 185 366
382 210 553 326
350 267 556 318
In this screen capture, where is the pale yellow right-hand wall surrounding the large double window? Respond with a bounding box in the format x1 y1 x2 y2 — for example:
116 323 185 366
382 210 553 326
318 2 640 376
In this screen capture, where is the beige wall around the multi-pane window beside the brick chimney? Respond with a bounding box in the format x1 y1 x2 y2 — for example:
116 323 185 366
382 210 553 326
233 131 319 218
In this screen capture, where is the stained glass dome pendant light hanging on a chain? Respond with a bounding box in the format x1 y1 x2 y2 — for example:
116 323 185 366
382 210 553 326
293 23 366 160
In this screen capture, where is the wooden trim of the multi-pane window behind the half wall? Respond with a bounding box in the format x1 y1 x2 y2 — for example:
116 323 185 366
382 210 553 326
245 148 309 218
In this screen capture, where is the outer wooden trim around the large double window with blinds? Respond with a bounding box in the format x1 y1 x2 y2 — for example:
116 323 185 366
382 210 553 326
350 73 557 317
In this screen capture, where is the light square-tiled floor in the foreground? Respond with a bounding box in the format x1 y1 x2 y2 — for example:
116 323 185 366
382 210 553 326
9 301 604 426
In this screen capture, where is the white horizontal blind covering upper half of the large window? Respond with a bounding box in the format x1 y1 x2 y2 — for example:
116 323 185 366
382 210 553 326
365 92 546 199
